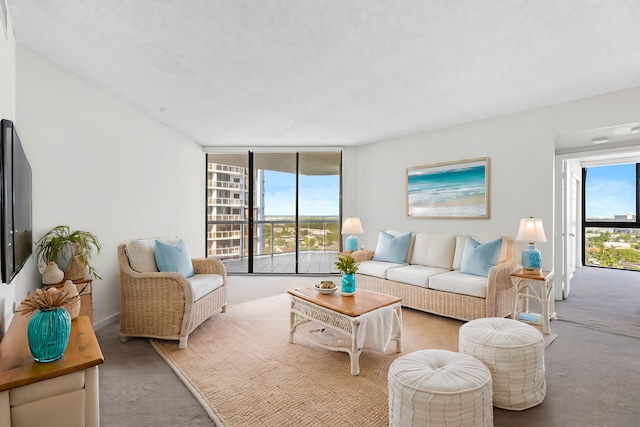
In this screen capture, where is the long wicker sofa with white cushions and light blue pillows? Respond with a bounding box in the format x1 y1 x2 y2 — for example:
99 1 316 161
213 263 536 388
353 232 519 320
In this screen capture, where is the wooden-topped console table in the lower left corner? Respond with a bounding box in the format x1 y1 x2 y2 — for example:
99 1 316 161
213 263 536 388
0 294 104 427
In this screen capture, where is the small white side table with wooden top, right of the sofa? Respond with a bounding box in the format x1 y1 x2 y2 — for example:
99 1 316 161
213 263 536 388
511 270 556 334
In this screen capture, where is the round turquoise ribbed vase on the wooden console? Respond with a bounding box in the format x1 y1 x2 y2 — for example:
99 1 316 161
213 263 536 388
27 308 71 362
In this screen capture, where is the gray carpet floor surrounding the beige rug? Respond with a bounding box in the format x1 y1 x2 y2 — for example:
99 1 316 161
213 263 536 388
96 268 640 427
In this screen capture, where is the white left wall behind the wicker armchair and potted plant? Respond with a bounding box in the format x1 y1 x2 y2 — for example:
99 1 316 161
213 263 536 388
11 45 205 324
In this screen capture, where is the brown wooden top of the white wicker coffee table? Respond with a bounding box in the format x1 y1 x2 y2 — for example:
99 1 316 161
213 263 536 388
287 288 402 317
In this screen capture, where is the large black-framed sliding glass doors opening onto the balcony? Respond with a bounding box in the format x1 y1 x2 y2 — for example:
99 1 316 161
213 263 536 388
206 152 341 274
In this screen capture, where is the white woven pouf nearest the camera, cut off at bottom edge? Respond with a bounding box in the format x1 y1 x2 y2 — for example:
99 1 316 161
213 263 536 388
388 350 493 427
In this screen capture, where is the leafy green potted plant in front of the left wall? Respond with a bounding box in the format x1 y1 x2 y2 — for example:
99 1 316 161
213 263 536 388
36 225 101 280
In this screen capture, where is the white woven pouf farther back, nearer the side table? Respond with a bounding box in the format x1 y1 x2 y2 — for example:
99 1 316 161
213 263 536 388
459 317 547 411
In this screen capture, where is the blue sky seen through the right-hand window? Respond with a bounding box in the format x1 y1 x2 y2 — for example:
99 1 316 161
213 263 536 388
586 164 636 218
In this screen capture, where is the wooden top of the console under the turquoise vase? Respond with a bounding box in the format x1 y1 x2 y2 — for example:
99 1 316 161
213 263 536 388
0 295 104 391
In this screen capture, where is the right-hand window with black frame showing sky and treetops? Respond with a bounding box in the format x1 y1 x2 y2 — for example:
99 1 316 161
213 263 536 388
582 163 640 270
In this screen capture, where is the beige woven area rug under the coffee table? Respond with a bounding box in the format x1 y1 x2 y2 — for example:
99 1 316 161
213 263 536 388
150 294 550 427
